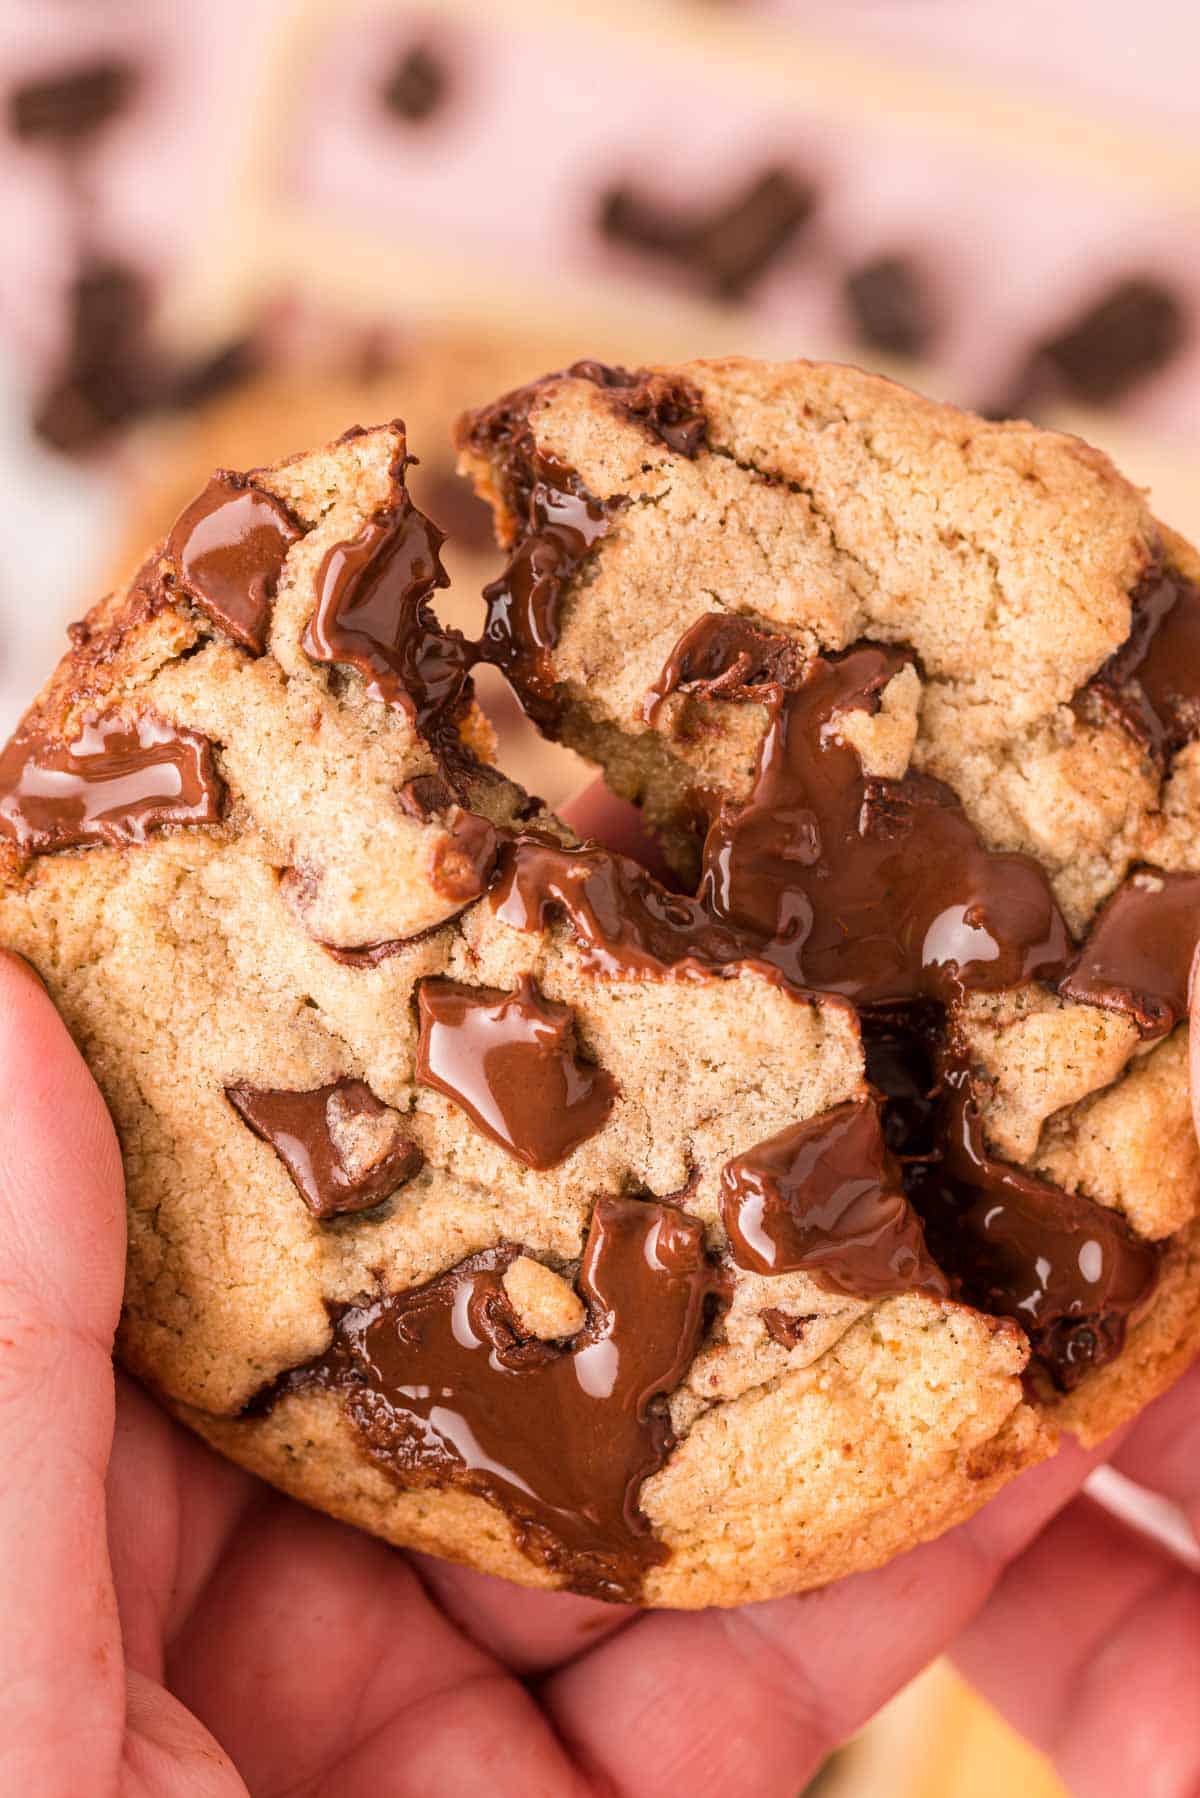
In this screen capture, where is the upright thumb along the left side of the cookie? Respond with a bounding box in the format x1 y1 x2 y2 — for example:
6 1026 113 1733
0 953 124 1793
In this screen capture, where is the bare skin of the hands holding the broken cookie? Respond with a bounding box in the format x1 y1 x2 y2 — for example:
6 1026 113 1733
0 797 1200 1798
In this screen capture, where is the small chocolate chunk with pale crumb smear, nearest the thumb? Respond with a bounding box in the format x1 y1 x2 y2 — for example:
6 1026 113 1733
225 1079 425 1219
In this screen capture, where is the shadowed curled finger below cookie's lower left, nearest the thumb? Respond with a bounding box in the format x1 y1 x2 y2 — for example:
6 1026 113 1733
169 1494 578 1798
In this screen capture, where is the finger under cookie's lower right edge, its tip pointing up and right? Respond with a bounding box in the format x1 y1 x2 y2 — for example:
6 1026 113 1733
542 1446 1092 1798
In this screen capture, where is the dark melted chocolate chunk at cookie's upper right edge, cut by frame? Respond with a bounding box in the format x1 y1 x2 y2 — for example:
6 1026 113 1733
1083 568 1200 761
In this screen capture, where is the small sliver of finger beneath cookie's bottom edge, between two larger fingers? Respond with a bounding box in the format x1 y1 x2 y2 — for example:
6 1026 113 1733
408 1555 642 1679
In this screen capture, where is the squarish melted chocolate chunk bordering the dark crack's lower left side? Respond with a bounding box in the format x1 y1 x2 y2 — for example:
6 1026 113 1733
721 1100 950 1300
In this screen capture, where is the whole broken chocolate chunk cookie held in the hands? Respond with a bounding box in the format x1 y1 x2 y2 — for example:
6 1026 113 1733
0 361 1200 1606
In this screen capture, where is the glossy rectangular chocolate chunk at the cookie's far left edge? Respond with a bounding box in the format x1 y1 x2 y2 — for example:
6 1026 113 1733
0 712 223 856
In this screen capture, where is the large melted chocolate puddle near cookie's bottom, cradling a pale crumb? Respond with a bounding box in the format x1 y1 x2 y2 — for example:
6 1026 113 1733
290 1197 712 1600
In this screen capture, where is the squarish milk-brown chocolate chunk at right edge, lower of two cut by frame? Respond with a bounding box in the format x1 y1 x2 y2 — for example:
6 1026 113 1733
1058 868 1200 1036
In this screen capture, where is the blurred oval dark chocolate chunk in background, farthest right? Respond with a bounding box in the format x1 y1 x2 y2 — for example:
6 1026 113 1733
1034 275 1189 406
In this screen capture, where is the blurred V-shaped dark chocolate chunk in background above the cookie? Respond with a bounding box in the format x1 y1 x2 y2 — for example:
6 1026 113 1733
599 167 817 300
